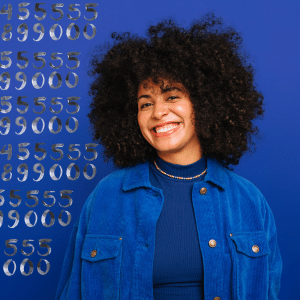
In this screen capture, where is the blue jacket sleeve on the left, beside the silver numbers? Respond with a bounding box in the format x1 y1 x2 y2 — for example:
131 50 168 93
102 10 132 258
55 186 98 300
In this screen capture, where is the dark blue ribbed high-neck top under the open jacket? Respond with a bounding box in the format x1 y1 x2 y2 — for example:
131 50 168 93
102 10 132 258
149 156 206 300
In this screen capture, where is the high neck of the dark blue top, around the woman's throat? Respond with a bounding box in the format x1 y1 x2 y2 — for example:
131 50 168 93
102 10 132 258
151 155 206 180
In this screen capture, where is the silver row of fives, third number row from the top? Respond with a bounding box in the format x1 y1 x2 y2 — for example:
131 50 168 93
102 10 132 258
0 51 80 69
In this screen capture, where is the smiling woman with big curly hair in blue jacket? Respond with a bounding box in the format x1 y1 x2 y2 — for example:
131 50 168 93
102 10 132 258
56 14 282 300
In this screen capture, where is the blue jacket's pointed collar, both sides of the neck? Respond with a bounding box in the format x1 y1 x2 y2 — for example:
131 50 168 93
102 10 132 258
123 156 225 191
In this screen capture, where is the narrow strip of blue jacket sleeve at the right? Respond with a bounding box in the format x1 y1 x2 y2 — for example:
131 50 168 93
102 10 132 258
265 198 282 300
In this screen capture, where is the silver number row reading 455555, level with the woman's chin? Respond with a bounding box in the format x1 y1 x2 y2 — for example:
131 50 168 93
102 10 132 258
0 143 98 161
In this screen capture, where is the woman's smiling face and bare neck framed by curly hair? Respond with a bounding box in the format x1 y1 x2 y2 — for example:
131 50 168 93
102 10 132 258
137 79 202 165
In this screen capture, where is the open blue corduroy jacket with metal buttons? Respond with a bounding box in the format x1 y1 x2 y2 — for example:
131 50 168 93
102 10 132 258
56 157 282 300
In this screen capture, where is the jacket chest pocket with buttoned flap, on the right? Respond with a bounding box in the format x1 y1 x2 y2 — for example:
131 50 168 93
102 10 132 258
230 231 269 300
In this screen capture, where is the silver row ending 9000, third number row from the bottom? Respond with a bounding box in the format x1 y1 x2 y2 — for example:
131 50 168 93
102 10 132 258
0 209 72 228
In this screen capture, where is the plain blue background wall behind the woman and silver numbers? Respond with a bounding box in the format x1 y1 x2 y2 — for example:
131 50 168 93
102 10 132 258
0 0 300 300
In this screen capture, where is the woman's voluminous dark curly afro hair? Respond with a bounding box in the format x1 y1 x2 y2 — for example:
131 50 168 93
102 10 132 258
88 13 264 170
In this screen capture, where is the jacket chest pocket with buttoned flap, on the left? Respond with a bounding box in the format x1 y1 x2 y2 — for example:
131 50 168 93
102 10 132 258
81 234 122 300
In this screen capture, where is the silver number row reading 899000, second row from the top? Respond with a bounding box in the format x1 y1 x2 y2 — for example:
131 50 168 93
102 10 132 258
1 23 97 42
